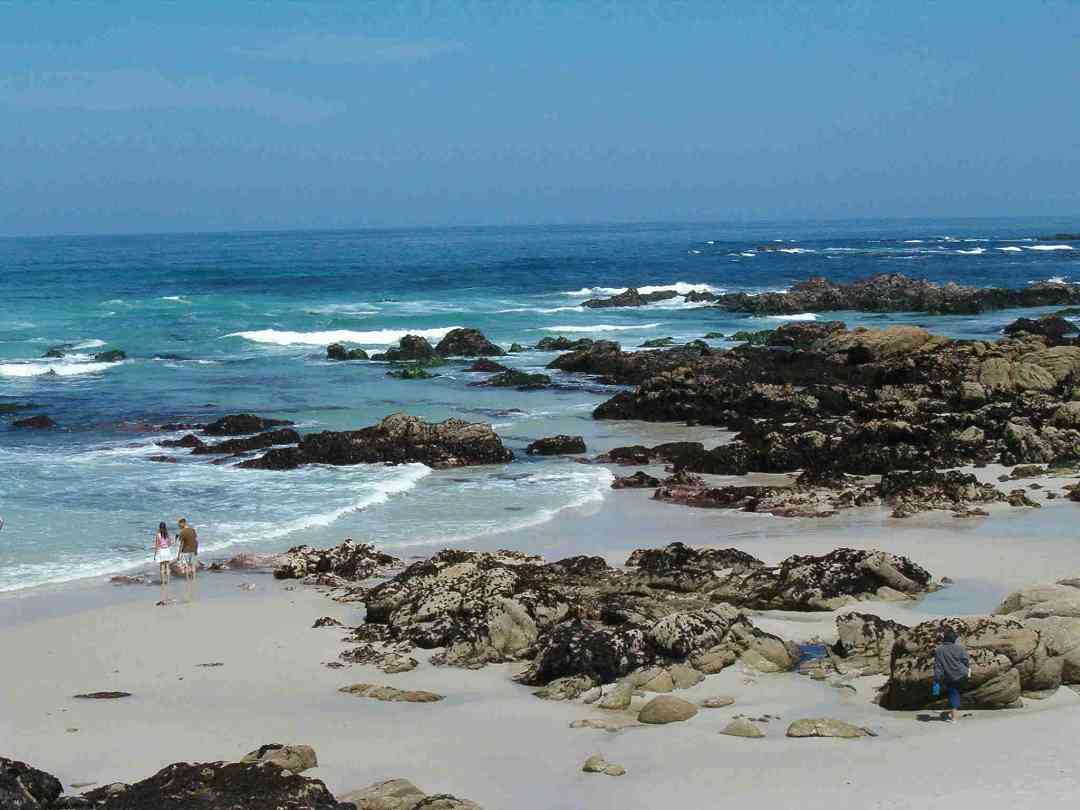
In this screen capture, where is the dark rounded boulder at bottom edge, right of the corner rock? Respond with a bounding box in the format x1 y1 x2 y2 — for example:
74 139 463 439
84 762 338 810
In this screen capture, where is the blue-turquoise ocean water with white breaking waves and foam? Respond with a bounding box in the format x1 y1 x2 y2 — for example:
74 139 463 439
0 219 1080 591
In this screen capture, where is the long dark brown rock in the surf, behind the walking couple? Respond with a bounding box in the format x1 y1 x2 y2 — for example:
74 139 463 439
241 414 513 470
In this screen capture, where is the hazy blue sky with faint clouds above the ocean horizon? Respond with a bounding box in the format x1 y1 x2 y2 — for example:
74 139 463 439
0 0 1080 234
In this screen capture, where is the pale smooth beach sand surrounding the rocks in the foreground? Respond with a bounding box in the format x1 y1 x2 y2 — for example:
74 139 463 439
6 473 1080 810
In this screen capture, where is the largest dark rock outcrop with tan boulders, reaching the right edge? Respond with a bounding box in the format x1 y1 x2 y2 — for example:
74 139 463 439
587 319 1080 488
